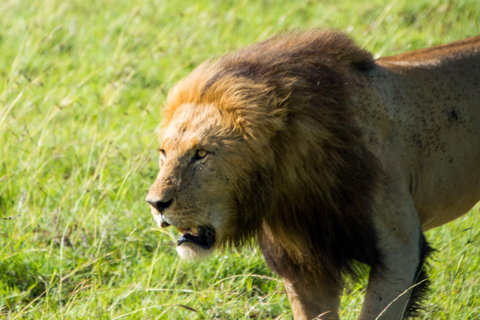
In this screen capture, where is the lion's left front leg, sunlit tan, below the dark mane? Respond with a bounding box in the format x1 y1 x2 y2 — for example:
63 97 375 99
285 277 342 320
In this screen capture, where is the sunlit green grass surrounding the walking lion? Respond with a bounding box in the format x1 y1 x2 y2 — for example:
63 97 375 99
0 0 480 320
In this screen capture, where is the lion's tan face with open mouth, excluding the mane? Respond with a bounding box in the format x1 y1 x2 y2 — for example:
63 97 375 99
146 104 255 260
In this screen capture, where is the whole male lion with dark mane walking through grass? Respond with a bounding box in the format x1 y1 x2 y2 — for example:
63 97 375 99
146 30 480 320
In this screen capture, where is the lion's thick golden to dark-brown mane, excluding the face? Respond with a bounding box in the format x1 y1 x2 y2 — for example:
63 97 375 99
164 31 381 281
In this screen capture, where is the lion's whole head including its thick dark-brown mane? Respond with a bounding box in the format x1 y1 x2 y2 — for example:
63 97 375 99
147 32 382 273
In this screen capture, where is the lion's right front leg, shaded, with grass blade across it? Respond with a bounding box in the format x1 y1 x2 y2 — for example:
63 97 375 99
358 186 430 320
